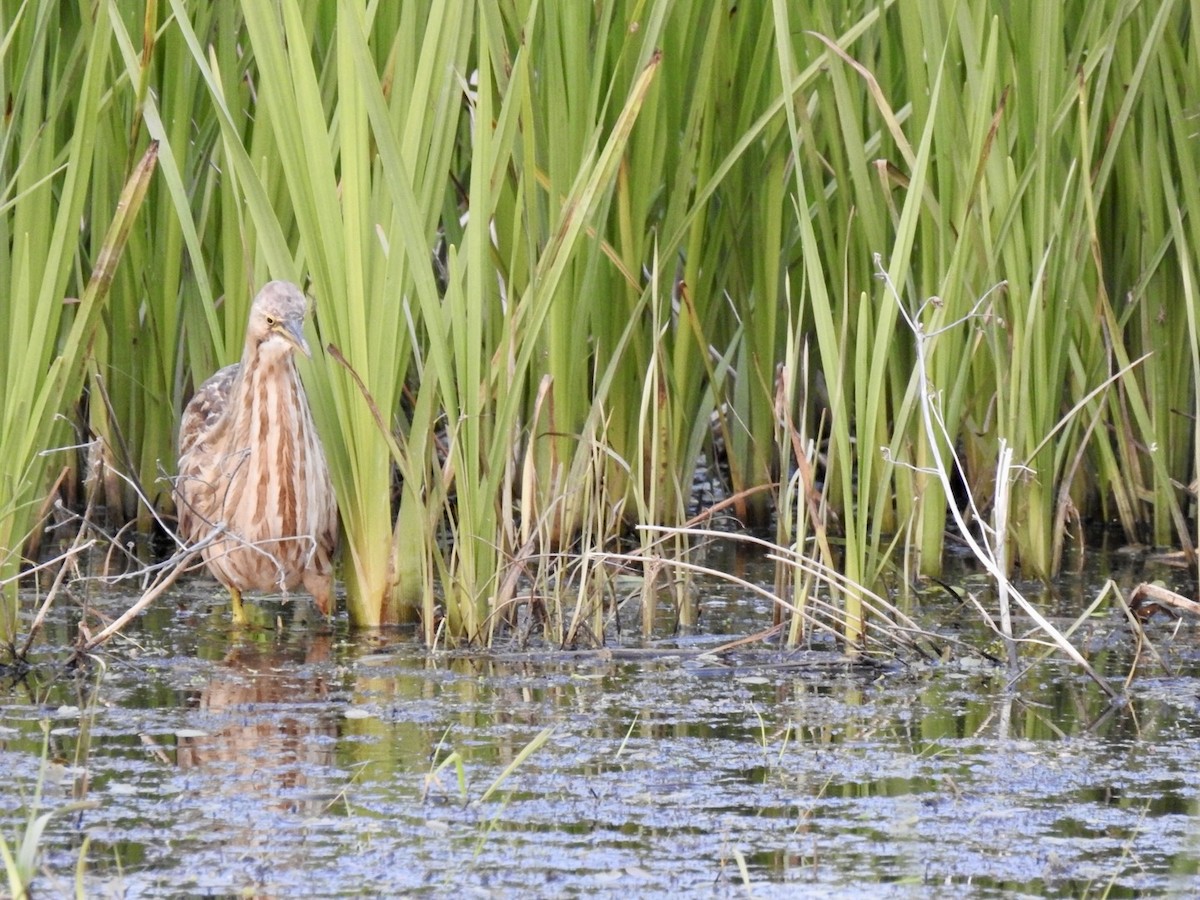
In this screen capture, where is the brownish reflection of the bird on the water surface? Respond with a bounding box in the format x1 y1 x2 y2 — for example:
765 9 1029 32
176 619 337 815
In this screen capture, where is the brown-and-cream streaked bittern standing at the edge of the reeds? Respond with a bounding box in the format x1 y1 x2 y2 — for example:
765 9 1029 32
175 281 337 623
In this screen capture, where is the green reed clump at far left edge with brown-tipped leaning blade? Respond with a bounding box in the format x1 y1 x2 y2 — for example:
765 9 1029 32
0 4 157 647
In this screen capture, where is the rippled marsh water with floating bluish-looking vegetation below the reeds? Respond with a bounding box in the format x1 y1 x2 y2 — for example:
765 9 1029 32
0 554 1200 898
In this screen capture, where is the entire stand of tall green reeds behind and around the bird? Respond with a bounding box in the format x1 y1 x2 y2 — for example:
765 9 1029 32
7 0 1200 644
